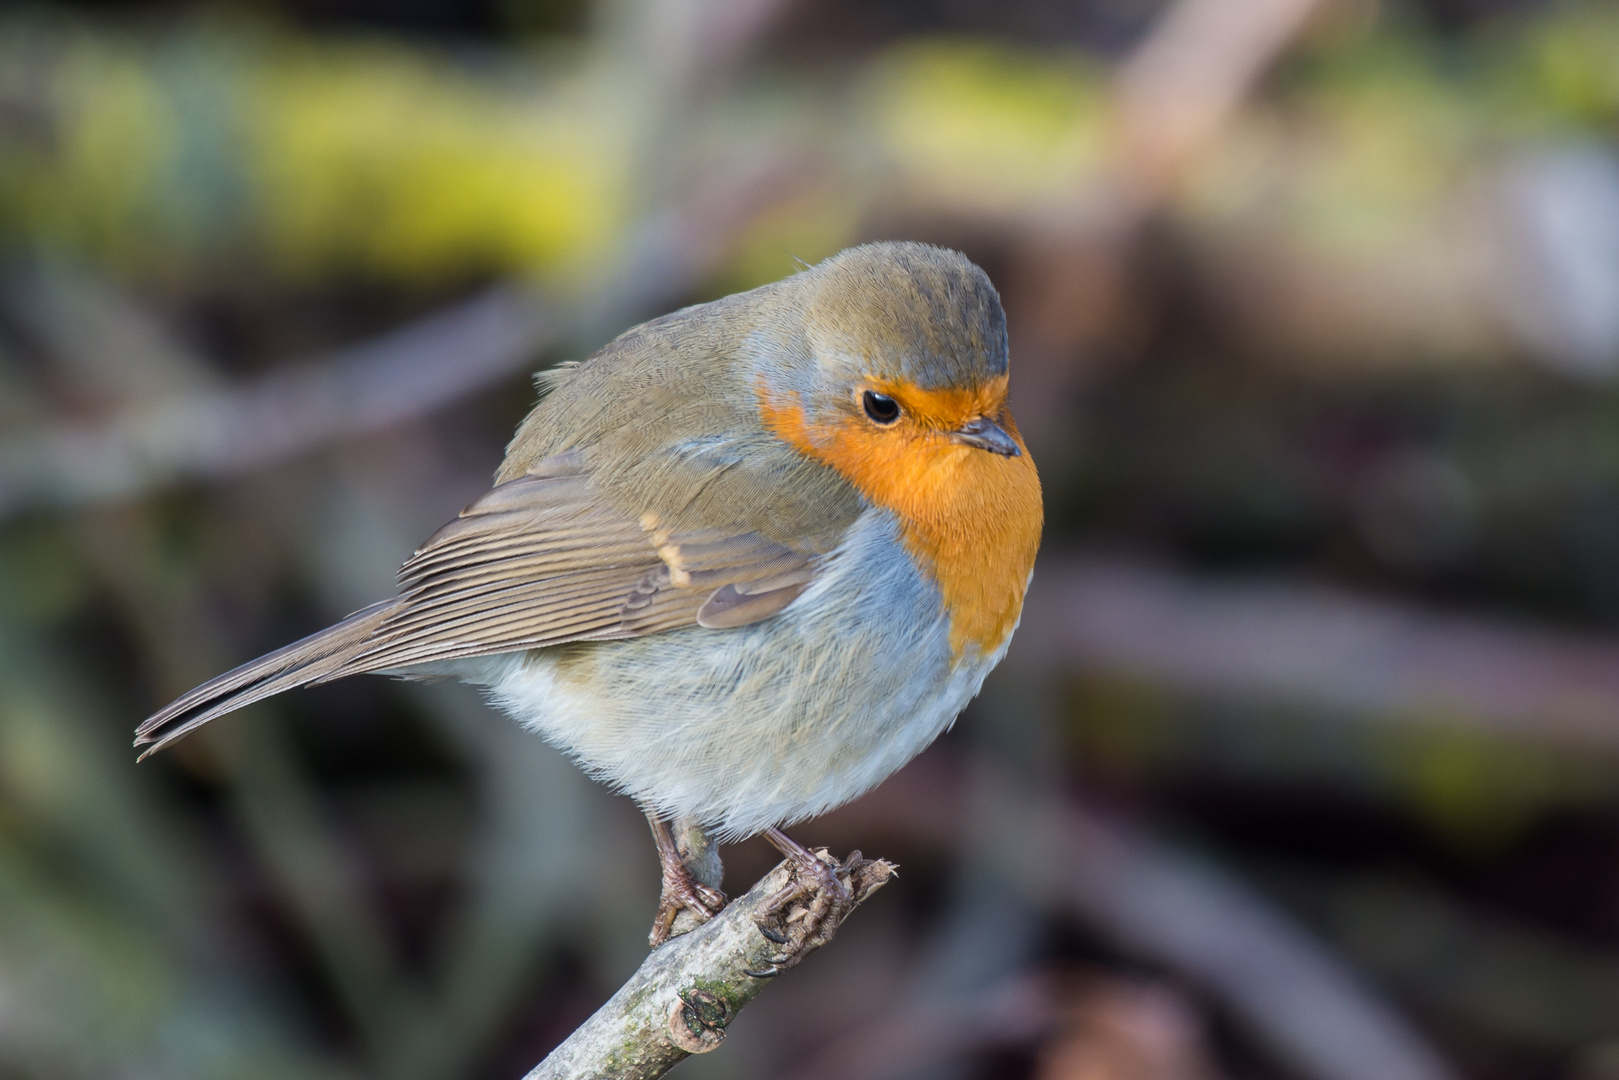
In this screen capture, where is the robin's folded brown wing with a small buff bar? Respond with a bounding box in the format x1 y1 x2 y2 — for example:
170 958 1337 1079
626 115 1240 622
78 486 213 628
321 453 818 682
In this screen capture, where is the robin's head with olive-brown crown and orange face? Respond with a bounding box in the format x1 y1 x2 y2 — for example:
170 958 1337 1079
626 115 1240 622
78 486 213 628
758 243 1039 537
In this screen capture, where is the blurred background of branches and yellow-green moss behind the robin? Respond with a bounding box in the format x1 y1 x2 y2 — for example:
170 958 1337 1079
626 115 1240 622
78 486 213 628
0 0 1619 1080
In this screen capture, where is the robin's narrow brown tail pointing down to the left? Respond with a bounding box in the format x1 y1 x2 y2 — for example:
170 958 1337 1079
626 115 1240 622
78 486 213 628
134 599 398 759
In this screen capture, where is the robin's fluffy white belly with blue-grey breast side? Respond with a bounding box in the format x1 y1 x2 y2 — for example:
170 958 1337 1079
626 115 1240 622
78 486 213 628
476 510 1005 839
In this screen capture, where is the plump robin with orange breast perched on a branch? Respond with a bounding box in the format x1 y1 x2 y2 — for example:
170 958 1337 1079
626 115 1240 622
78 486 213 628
136 241 1044 963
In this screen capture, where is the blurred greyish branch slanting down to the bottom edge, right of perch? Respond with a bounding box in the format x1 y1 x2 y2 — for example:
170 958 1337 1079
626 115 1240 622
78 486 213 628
827 757 1455 1080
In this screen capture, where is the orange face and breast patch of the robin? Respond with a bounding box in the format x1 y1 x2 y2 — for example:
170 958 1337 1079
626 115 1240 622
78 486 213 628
759 376 1044 656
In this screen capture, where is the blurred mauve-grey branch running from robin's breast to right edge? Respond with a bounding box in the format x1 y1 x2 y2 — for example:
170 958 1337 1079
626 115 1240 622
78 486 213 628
1020 559 1619 750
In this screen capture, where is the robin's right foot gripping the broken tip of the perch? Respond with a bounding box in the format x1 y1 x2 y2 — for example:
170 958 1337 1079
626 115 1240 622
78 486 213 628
750 831 894 978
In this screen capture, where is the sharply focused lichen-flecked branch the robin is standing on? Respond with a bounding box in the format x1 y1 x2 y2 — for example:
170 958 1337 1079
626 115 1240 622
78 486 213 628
526 860 894 1080
